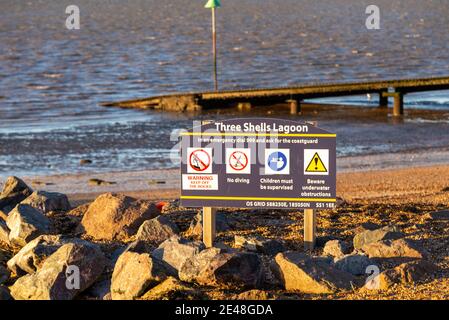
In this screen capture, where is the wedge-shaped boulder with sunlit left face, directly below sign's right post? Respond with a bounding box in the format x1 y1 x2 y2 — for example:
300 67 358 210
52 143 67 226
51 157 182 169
273 252 355 294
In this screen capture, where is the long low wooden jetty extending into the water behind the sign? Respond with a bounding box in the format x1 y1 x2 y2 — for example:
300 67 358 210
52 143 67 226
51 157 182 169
101 77 449 116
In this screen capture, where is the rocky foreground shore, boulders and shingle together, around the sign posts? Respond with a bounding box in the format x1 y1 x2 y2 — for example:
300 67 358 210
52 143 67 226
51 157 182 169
0 177 449 300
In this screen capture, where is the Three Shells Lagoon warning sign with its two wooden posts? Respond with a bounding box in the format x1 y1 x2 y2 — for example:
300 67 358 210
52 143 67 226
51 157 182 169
181 118 336 250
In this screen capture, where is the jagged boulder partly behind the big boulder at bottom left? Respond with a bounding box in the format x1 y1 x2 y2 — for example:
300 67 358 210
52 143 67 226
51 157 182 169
8 235 67 274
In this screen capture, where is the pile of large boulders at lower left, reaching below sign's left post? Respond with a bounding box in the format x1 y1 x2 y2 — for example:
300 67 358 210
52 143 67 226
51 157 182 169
0 177 262 299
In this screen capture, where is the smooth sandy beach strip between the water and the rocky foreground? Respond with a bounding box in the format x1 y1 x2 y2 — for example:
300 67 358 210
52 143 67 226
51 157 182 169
0 156 449 206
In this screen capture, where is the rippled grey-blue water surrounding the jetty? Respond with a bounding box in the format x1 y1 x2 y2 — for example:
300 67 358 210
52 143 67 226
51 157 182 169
0 0 449 176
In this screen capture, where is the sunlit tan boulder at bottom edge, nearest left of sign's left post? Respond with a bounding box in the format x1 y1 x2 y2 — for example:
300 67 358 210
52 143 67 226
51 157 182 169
111 252 169 300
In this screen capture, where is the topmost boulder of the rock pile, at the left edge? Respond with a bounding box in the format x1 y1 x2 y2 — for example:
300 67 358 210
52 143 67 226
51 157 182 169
0 177 33 213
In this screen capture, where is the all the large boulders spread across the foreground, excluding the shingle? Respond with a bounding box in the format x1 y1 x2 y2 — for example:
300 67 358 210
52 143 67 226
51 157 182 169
0 177 441 300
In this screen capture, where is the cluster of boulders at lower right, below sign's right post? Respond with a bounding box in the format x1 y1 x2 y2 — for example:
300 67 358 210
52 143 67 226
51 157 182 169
272 226 437 294
